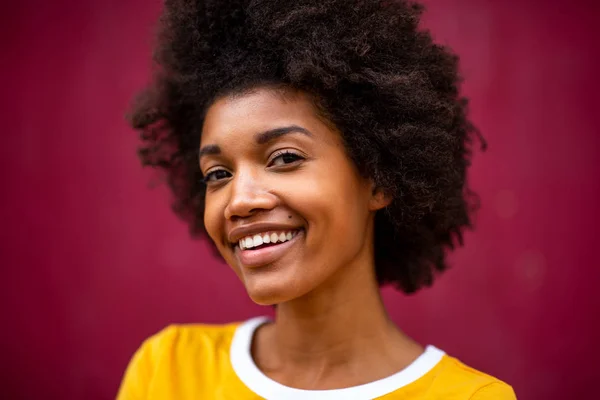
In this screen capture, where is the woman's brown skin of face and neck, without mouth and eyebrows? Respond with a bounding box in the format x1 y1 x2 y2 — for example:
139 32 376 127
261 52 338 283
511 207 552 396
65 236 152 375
200 87 423 389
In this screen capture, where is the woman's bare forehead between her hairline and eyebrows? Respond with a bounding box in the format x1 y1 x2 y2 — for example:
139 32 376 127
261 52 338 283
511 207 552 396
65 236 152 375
201 88 323 144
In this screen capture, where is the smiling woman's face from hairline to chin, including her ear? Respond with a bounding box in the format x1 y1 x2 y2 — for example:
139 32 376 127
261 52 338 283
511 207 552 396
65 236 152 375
199 88 385 304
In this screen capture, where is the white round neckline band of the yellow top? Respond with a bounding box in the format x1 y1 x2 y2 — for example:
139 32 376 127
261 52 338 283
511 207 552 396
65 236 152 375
230 317 445 400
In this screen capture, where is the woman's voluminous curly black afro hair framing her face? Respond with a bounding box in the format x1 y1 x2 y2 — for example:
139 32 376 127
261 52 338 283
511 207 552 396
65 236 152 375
130 0 485 293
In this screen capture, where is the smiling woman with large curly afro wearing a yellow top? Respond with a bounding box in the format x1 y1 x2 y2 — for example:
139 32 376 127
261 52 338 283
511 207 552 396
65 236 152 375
119 0 515 399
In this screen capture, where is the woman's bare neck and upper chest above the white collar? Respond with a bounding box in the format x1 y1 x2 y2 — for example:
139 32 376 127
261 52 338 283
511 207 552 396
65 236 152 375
253 252 419 376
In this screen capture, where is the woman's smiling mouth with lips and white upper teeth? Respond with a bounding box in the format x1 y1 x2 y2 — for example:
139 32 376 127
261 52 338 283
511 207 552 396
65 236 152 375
233 229 304 268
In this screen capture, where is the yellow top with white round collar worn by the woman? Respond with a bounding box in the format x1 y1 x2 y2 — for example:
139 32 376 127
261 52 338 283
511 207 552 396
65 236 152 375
117 318 516 400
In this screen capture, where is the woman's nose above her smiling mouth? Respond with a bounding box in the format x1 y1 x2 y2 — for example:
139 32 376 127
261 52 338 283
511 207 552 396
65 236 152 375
225 171 277 220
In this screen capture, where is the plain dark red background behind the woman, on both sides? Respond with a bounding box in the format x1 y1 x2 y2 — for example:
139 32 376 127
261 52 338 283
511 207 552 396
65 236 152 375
0 0 600 400
